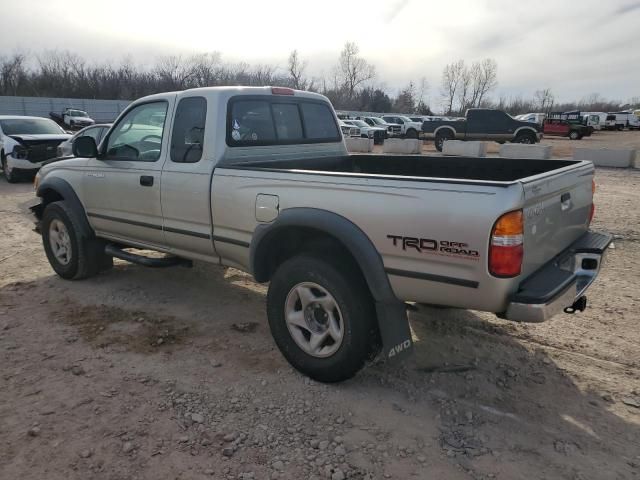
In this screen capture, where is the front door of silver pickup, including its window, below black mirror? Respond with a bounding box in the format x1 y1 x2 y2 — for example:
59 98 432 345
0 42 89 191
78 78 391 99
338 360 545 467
83 96 175 246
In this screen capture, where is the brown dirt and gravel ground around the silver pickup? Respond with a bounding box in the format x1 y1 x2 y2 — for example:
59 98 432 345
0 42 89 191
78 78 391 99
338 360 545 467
0 151 640 480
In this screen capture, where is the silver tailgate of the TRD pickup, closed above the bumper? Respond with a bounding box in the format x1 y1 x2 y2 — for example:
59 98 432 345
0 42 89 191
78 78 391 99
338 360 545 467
522 162 594 277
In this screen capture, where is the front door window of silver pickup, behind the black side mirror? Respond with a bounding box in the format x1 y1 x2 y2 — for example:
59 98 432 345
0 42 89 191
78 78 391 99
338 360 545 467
105 101 167 162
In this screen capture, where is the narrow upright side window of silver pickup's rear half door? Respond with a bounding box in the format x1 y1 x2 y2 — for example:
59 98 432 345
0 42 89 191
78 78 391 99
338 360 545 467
171 97 207 163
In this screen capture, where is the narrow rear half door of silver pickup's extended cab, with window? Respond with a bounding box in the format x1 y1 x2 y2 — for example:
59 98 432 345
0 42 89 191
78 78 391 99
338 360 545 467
162 96 215 257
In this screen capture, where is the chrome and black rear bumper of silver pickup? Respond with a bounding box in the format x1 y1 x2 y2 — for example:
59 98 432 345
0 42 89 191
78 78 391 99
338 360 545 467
504 232 611 322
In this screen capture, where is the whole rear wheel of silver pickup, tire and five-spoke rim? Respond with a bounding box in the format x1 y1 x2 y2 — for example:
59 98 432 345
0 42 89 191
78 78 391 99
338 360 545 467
267 254 377 382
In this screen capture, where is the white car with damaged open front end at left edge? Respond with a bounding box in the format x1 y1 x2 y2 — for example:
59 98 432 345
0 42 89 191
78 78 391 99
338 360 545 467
0 115 71 183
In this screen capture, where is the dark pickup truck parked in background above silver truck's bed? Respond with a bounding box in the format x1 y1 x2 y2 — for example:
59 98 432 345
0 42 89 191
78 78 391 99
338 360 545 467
422 108 542 152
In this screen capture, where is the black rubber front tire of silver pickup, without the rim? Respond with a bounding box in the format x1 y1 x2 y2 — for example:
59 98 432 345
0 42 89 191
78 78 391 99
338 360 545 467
40 201 113 280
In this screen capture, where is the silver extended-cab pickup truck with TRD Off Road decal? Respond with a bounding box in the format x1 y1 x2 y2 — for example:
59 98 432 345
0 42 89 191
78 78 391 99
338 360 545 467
32 87 610 382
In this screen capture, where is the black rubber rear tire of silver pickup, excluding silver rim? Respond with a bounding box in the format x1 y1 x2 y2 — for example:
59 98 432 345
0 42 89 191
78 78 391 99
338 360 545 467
267 254 379 382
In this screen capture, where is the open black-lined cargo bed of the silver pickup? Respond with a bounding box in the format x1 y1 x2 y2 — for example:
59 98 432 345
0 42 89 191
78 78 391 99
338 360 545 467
231 155 579 182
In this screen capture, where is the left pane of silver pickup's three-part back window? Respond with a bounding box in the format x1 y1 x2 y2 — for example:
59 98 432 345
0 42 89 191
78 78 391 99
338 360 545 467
230 100 276 145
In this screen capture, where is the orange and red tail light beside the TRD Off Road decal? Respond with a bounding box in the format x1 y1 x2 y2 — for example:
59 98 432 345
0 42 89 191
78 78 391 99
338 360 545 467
489 210 524 277
